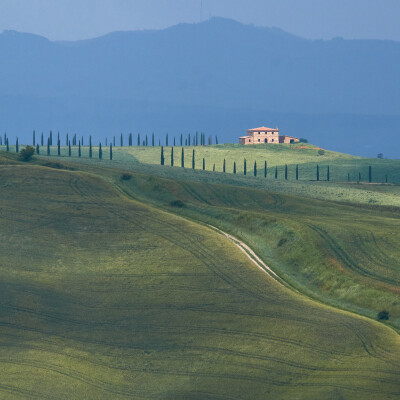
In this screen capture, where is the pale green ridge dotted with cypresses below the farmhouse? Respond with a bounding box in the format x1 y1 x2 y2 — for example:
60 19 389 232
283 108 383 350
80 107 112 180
0 143 400 206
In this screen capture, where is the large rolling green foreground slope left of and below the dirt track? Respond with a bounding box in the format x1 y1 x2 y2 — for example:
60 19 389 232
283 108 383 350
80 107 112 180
0 161 400 399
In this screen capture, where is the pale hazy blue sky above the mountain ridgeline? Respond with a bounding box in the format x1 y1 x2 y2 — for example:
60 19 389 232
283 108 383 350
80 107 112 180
0 0 400 41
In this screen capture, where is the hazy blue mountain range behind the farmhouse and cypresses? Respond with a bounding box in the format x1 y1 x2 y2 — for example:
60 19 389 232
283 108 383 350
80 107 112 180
0 18 400 158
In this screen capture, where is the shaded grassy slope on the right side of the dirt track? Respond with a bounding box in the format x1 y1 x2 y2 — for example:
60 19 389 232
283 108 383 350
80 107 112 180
115 174 400 328
